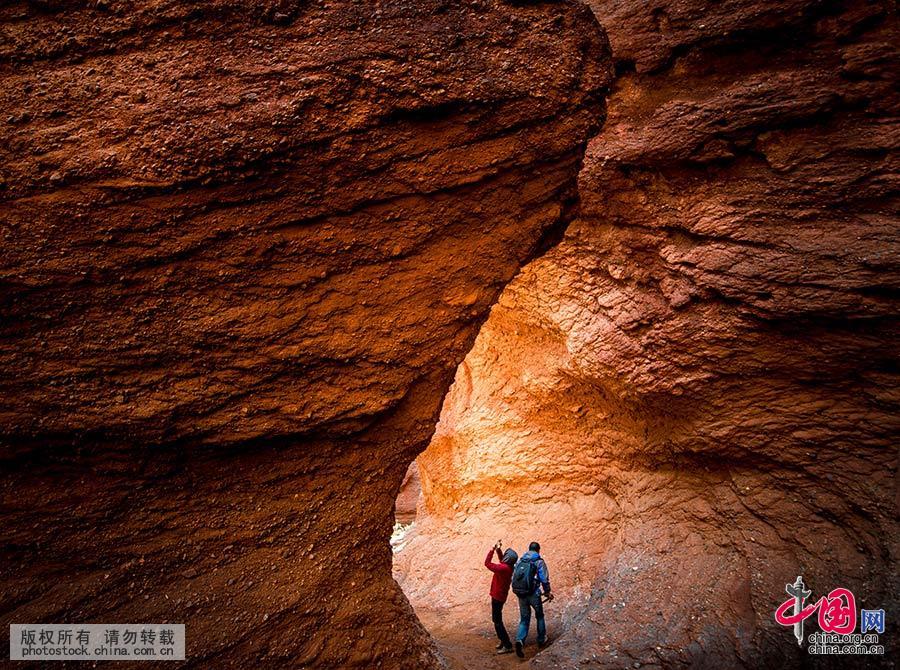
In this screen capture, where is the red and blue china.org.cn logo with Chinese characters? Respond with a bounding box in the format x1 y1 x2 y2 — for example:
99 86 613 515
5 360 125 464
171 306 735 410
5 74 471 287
775 577 884 655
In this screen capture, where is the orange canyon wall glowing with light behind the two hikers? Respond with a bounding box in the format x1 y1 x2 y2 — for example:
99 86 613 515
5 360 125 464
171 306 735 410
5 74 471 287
398 2 900 668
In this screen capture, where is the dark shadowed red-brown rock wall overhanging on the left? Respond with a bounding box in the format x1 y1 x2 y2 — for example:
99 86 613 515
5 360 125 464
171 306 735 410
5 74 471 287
0 0 612 668
